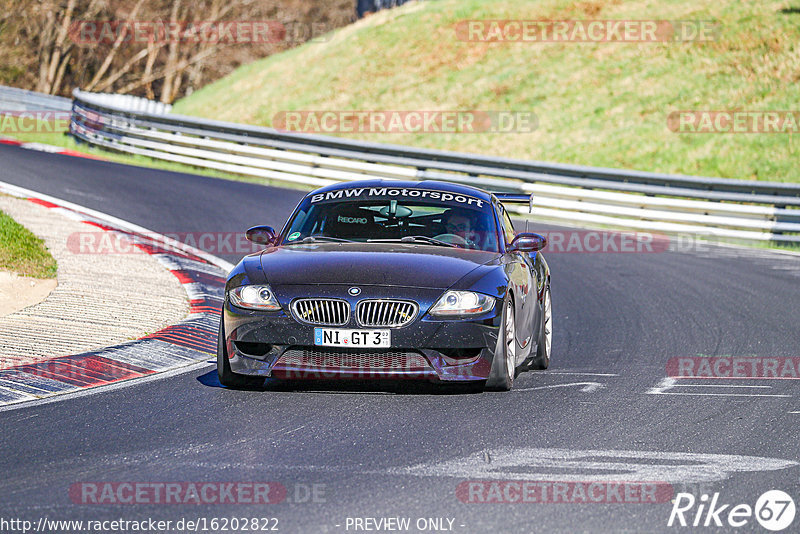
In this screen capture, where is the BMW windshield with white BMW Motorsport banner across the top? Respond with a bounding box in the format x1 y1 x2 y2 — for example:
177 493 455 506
281 188 498 252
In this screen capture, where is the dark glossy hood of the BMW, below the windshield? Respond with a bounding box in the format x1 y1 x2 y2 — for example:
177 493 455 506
261 243 500 289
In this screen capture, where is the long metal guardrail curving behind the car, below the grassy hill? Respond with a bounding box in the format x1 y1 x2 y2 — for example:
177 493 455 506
47 90 800 242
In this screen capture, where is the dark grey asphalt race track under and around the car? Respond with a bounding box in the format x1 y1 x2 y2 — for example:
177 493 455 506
0 146 800 532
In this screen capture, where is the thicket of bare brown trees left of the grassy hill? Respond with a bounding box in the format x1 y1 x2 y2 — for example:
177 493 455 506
0 0 353 102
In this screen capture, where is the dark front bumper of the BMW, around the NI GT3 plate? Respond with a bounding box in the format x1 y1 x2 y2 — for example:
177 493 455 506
223 286 502 382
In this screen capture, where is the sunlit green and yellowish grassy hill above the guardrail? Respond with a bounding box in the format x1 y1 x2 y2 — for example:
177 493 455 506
175 0 800 181
